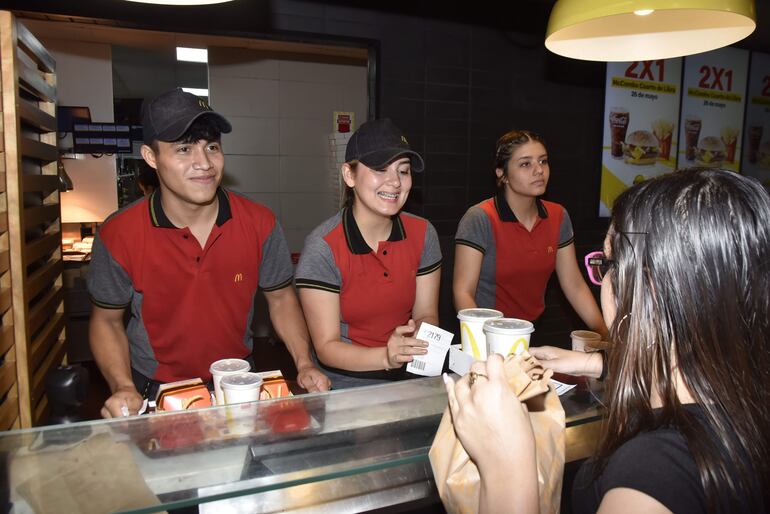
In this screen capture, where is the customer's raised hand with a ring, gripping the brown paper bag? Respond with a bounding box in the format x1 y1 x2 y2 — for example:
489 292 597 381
444 354 535 476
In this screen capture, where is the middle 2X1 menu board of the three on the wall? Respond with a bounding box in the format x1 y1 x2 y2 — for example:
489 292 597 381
678 47 749 171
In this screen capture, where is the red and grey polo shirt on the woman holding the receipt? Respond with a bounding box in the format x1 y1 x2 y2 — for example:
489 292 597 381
295 208 441 347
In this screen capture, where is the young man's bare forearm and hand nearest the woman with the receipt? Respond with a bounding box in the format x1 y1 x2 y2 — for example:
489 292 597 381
265 286 331 393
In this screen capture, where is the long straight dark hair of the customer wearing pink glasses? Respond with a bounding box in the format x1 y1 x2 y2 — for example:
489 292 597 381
595 168 770 512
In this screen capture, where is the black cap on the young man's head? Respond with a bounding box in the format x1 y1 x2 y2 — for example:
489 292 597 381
142 88 233 145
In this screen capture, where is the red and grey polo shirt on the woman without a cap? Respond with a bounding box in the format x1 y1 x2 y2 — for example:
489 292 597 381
455 192 575 321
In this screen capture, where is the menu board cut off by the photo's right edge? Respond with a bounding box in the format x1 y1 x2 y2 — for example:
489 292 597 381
742 52 770 189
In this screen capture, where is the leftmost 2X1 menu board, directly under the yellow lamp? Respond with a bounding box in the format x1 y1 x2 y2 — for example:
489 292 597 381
599 58 682 216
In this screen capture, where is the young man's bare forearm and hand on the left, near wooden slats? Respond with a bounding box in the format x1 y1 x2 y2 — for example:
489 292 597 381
88 305 142 418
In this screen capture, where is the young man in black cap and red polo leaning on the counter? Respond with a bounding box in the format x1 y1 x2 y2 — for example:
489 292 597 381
88 89 329 417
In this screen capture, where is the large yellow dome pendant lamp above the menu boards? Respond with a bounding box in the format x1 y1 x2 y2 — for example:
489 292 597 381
545 0 752 61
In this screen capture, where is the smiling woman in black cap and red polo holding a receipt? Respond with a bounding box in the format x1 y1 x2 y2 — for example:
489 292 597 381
295 119 441 389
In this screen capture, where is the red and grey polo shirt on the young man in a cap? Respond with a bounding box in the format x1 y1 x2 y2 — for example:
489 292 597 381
88 188 293 382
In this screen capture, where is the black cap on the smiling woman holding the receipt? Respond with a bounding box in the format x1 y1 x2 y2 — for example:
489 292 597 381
345 118 425 171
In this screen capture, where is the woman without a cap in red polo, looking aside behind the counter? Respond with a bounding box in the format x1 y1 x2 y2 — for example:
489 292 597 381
452 130 607 336
